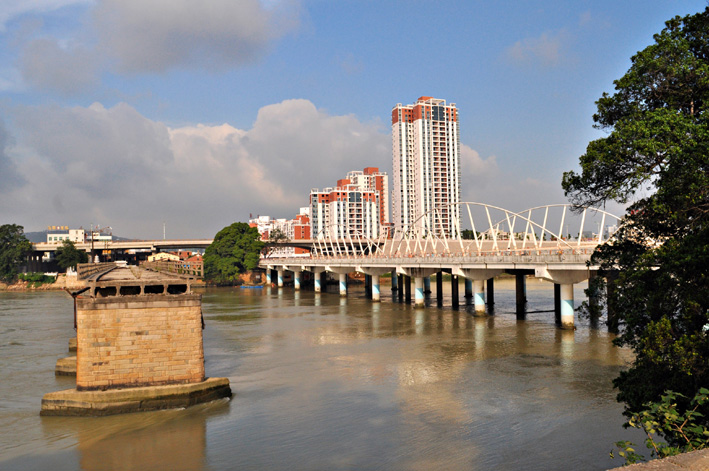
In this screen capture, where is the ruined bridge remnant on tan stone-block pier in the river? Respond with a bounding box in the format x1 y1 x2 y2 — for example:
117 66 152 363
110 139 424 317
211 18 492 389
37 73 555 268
41 265 231 415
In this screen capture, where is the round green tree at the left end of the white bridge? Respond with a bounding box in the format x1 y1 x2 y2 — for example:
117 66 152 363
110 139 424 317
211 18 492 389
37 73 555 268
204 222 264 284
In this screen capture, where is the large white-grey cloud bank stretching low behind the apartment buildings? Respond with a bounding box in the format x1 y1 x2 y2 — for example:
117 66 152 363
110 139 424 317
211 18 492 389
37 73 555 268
0 100 391 238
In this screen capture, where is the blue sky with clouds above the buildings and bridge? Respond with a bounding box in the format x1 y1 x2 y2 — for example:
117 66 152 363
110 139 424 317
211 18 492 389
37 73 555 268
0 0 706 239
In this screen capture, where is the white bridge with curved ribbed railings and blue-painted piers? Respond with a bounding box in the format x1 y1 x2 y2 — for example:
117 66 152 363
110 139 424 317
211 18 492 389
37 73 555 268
260 202 620 328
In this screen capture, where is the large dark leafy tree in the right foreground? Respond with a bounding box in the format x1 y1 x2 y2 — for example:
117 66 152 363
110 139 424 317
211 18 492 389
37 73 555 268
562 8 709 456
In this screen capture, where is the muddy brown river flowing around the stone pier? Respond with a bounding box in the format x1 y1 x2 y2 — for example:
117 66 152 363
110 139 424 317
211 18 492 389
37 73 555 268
0 279 642 470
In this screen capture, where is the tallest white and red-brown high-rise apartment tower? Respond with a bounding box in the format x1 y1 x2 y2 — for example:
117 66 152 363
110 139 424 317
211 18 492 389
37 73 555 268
391 96 460 237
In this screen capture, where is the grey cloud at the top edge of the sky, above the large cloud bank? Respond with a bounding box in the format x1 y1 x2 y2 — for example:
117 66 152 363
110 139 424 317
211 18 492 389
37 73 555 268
94 0 299 73
